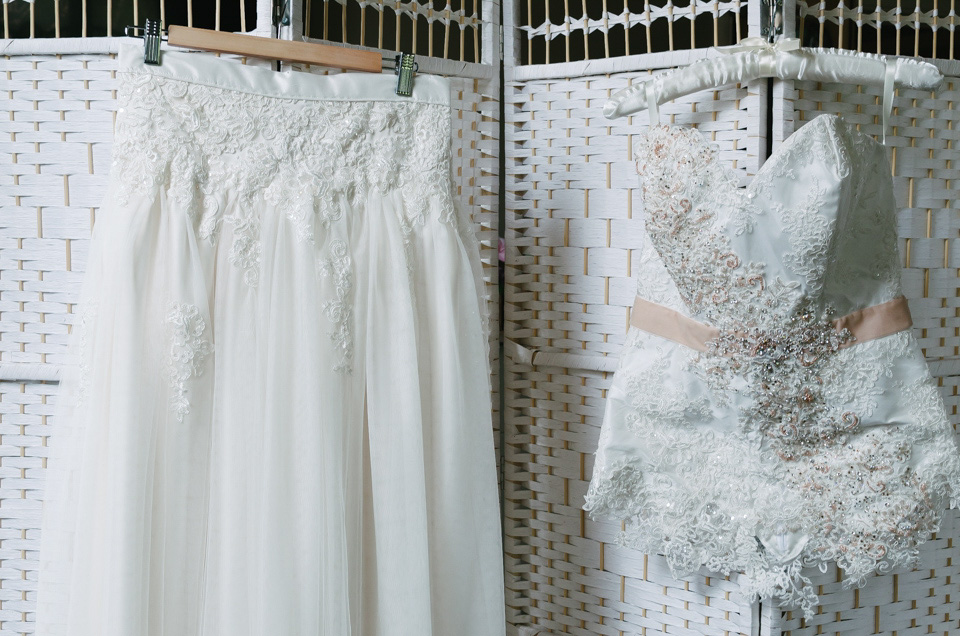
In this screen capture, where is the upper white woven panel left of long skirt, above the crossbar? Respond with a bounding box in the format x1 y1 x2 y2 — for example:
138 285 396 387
0 55 116 364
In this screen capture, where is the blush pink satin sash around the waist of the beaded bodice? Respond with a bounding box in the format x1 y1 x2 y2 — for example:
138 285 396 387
630 296 913 351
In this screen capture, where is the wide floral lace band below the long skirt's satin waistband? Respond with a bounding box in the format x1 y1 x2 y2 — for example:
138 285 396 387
112 73 453 285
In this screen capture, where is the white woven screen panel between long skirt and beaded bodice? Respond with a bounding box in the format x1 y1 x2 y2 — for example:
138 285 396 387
503 66 766 636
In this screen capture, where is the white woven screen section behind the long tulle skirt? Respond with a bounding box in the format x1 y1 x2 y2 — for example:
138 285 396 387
0 55 500 636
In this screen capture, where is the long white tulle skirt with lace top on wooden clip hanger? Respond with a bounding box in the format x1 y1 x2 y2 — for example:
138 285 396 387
35 44 505 636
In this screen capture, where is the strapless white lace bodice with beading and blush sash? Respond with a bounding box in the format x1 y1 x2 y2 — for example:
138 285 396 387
585 115 960 617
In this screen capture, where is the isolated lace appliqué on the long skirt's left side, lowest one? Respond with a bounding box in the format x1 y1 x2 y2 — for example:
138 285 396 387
167 303 213 422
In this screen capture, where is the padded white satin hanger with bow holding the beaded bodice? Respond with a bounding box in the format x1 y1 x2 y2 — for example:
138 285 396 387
603 37 943 141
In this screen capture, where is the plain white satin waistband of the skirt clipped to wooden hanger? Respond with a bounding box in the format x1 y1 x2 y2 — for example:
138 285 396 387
117 42 450 106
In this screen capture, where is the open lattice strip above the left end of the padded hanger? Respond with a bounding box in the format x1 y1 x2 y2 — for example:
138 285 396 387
506 0 747 65
